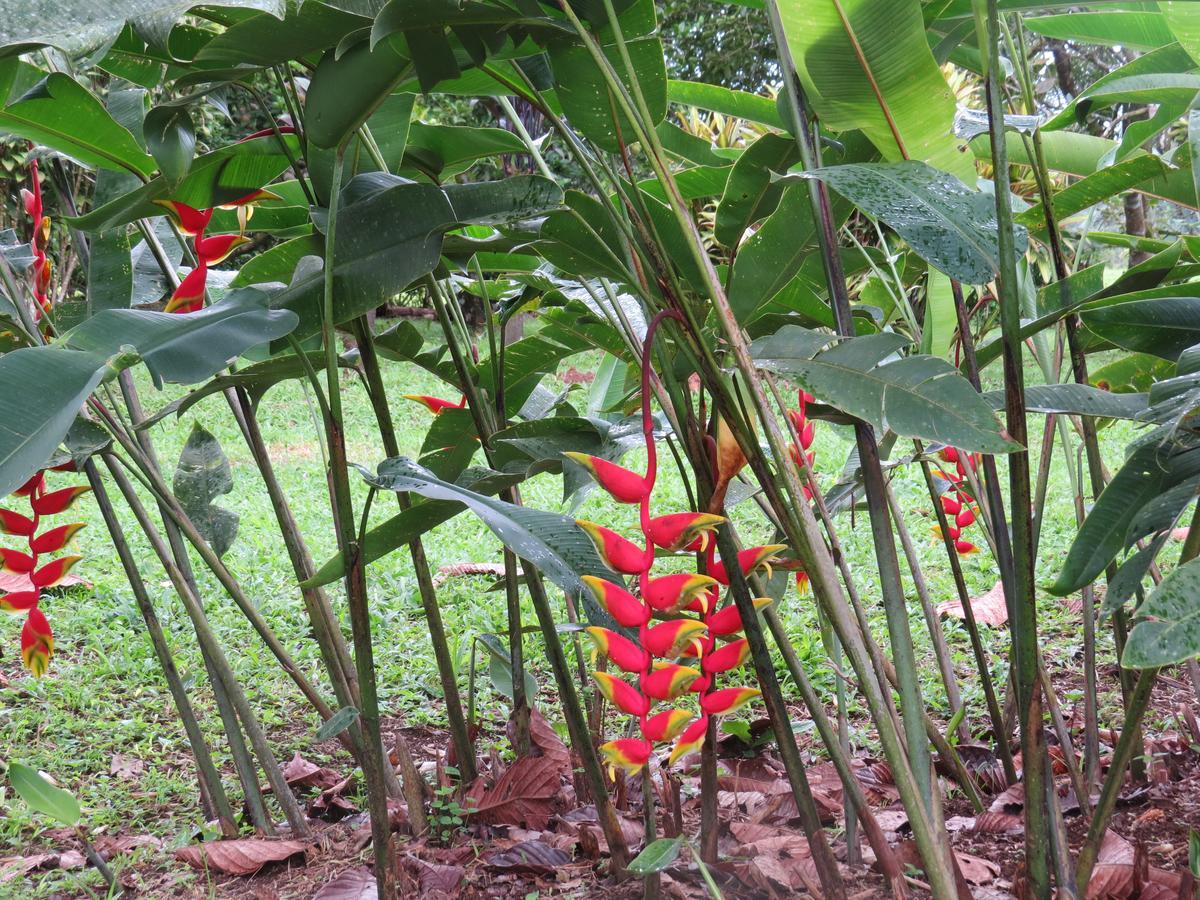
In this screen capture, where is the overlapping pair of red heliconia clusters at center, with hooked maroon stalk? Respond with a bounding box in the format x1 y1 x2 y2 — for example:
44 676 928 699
566 314 763 773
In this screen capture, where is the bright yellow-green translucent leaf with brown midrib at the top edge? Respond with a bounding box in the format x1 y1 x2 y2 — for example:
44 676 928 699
780 0 976 184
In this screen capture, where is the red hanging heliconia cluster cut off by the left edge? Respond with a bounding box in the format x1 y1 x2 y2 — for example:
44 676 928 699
0 472 91 678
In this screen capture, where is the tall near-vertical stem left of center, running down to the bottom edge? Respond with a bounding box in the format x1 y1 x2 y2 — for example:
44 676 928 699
320 144 391 900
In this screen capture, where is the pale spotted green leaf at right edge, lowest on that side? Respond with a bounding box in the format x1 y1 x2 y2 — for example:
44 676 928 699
1121 559 1200 668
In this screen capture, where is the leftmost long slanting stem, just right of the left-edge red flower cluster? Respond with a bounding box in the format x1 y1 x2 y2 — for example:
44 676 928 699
84 460 238 838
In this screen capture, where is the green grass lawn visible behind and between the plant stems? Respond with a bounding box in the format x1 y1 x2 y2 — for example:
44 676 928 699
0 328 1152 896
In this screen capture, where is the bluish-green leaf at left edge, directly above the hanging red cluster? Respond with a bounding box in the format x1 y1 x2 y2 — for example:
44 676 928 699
0 347 124 497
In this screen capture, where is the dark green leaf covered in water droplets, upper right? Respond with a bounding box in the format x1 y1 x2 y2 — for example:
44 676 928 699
800 161 1028 284
